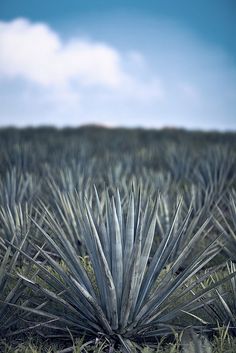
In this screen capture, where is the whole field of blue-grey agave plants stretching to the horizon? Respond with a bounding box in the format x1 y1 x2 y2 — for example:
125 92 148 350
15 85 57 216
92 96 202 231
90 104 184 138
0 127 236 353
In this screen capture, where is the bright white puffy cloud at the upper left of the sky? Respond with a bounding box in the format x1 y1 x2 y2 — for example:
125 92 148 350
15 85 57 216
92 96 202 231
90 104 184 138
0 19 127 87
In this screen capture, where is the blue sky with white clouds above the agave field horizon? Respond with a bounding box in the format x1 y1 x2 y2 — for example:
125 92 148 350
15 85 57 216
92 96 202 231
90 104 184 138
0 0 236 130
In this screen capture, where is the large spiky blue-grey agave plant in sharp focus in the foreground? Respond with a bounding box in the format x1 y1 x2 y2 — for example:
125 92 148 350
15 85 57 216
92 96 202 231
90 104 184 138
13 190 233 351
